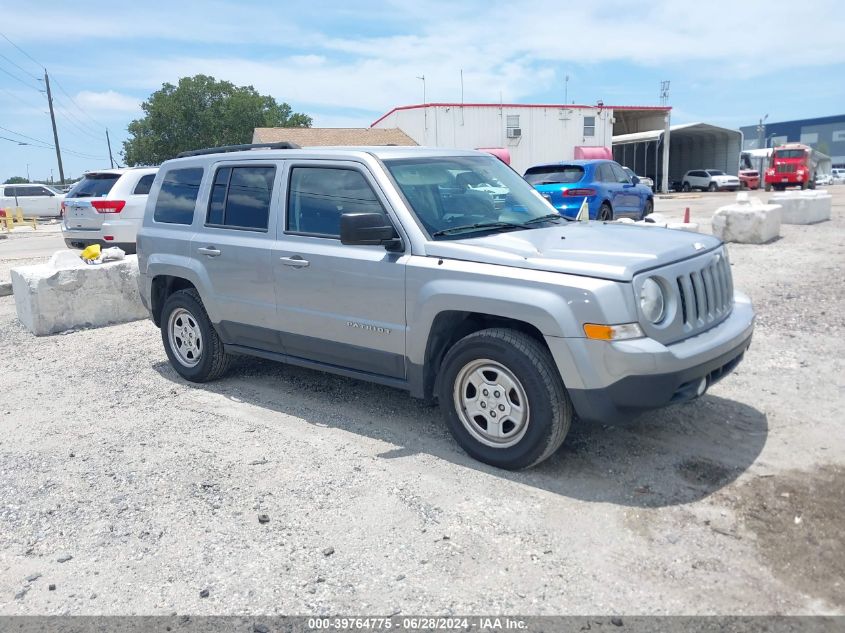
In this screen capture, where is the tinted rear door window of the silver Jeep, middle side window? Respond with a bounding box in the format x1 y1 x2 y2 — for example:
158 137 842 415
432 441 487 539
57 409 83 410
206 166 276 231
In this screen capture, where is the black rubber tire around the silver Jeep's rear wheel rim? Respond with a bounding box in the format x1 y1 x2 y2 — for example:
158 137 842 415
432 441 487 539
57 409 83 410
161 288 229 382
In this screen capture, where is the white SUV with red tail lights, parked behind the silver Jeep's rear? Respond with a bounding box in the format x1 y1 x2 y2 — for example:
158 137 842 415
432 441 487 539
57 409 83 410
62 167 158 253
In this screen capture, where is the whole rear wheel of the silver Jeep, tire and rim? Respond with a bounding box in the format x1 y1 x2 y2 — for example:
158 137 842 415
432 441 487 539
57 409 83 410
161 289 229 382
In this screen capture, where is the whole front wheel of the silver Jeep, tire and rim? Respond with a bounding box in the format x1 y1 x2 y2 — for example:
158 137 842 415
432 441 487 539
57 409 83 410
437 328 573 470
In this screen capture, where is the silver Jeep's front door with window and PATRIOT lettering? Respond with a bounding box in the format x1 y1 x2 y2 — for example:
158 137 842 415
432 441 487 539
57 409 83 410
273 161 407 379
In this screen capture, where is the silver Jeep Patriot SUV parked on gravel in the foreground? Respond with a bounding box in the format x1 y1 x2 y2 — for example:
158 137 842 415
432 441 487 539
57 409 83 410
138 143 754 469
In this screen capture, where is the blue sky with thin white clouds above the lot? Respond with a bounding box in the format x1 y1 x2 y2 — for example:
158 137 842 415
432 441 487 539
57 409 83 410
0 0 845 182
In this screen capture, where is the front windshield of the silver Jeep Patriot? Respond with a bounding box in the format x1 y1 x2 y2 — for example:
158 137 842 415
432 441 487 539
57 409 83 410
384 156 565 239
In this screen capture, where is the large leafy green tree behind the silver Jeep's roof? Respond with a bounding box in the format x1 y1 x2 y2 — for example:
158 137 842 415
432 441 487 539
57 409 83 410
123 75 311 165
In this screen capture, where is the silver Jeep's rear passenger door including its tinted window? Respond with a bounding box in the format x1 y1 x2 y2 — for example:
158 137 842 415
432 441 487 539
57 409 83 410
191 160 281 352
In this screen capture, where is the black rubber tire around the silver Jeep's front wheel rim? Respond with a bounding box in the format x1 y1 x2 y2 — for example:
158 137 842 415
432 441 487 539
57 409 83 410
437 328 573 470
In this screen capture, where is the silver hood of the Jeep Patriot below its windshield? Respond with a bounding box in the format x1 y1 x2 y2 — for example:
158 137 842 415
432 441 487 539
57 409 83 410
426 222 721 281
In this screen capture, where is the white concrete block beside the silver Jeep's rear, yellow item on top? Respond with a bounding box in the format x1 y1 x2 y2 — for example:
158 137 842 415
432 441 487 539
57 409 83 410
12 251 149 336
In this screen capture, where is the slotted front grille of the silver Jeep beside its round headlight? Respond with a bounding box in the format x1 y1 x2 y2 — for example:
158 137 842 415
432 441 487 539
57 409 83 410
675 255 733 330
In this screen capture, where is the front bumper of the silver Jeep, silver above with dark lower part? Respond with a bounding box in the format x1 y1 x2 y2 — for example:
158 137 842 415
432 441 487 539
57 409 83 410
550 293 754 422
